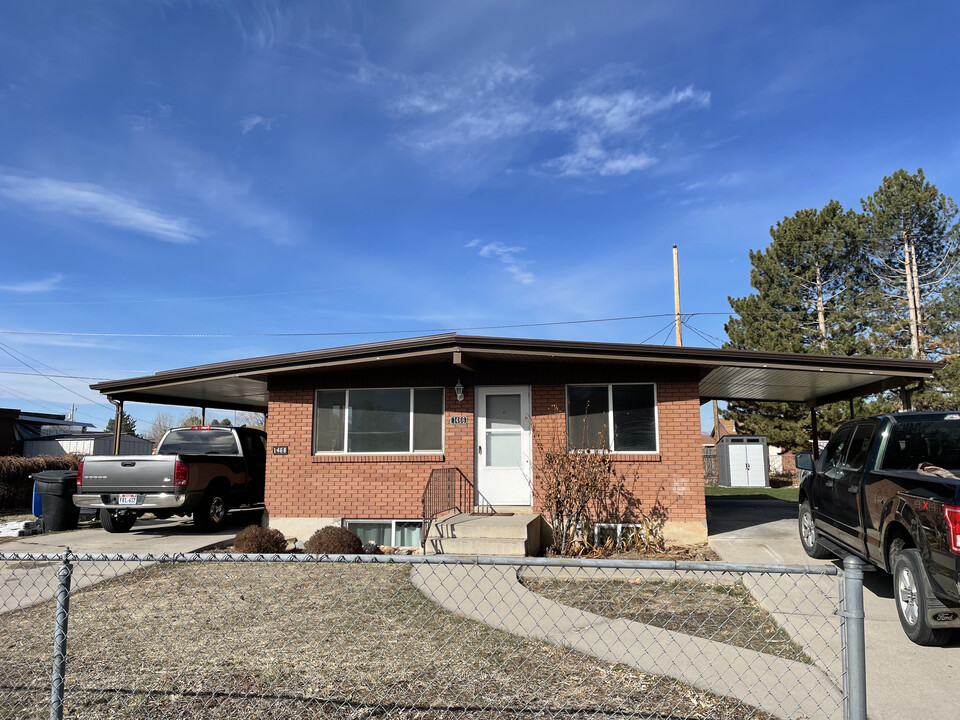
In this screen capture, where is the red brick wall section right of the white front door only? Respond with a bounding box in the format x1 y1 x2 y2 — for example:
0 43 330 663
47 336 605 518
532 382 706 522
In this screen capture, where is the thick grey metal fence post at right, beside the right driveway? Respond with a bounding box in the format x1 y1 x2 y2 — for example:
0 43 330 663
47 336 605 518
840 555 867 720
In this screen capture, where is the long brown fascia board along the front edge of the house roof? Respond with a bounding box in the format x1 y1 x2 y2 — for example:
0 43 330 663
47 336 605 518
90 333 943 393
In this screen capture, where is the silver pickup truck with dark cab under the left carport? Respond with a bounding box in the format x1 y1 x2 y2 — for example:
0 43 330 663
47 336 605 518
73 426 267 532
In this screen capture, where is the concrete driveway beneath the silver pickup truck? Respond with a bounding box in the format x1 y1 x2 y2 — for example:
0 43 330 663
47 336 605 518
0 513 251 613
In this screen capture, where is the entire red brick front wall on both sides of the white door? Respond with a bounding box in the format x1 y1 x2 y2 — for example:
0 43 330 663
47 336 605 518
266 382 706 522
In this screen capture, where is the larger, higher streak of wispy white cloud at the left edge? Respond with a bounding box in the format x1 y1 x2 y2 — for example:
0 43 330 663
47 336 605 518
0 174 202 243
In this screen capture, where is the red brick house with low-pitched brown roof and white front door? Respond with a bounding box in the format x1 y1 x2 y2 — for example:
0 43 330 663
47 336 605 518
92 334 939 545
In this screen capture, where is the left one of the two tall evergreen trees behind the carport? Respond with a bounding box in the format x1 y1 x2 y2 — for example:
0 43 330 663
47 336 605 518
724 200 877 450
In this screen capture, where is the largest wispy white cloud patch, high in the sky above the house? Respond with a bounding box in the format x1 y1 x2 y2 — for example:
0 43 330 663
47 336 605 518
378 58 710 177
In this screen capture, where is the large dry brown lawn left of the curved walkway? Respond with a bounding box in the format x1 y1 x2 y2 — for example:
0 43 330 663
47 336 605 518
0 562 769 720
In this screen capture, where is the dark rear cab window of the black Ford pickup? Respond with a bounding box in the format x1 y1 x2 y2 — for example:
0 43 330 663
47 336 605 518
881 416 960 470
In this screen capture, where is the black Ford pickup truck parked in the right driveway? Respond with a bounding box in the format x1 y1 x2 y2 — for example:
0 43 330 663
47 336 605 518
797 412 960 645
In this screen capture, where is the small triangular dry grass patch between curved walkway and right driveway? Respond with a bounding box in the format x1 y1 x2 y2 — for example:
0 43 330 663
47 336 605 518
523 577 811 664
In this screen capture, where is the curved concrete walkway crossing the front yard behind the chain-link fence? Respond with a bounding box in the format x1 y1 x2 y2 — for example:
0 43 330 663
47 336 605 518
411 565 843 720
